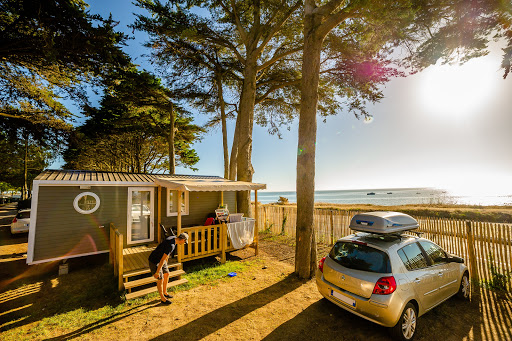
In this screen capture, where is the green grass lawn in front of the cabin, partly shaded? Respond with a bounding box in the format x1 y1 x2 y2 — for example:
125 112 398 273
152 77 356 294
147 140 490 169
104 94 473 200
0 254 261 340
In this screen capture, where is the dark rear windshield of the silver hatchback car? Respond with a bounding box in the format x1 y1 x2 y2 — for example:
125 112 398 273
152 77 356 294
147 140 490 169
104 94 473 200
329 242 391 273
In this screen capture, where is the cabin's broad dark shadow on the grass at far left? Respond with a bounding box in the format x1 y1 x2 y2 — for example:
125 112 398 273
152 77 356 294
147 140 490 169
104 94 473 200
0 255 123 331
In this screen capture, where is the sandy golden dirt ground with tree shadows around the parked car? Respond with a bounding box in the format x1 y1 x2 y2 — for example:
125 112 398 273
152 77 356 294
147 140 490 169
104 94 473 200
0 203 512 341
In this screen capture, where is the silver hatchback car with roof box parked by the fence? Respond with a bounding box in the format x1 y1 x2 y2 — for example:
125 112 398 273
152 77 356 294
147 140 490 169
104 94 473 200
316 212 470 340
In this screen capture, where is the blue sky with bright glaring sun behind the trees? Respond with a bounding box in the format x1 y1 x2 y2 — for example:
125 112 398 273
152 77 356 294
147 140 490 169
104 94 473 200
64 0 512 195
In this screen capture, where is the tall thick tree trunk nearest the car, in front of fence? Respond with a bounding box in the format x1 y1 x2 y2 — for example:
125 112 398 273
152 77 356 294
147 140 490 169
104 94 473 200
295 13 323 279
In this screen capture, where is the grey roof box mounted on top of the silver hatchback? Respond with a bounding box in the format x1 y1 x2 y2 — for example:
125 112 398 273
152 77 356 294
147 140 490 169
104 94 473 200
349 212 419 234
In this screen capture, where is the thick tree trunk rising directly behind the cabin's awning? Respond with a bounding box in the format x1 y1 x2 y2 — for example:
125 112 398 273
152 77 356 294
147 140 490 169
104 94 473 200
237 54 257 217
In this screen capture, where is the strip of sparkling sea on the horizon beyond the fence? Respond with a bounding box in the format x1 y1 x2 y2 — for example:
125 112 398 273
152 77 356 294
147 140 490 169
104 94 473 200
252 188 512 206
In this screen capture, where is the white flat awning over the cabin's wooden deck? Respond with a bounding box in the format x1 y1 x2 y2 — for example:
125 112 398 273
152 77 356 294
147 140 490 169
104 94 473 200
155 178 267 192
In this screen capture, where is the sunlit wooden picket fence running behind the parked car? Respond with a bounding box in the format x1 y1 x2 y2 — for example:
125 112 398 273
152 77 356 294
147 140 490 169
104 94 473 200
253 205 512 291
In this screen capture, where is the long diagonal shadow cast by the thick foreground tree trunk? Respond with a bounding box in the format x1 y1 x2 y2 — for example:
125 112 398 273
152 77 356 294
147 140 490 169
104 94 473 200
153 275 304 341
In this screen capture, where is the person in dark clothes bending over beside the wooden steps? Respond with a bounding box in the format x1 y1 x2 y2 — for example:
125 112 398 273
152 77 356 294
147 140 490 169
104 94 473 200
149 233 188 304
